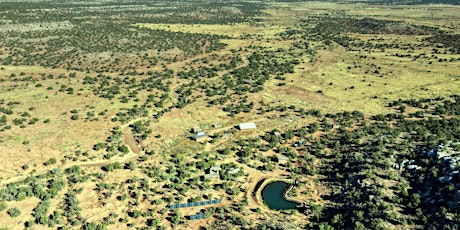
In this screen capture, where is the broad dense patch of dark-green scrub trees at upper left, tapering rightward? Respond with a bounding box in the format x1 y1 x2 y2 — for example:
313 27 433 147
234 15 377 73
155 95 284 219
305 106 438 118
1 22 223 72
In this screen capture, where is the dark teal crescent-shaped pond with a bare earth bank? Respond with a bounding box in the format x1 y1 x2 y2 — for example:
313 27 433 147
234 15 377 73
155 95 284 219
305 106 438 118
262 181 299 210
